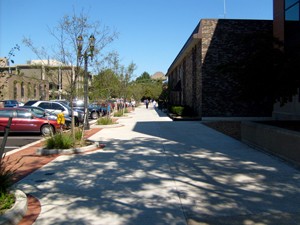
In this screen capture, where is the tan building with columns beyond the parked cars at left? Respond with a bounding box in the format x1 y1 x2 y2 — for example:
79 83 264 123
0 58 83 102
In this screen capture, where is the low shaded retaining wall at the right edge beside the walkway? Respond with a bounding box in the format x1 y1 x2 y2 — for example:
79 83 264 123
241 122 300 166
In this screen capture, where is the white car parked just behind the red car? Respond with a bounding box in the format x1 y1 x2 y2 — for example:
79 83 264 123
25 101 84 126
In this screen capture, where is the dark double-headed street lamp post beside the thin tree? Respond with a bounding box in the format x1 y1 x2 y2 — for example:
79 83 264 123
77 35 96 130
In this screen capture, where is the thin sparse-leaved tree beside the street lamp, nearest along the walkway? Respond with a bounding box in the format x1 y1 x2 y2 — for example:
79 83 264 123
23 10 118 141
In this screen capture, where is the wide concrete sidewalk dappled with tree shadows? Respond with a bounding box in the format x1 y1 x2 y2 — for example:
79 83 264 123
17 107 300 225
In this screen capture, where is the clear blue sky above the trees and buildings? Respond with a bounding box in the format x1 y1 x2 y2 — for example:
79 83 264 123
0 0 273 77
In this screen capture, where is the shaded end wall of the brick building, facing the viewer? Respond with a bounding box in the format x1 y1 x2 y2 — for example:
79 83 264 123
201 20 272 116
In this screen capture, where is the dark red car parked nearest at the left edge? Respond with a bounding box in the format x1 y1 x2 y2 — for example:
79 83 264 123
0 108 60 135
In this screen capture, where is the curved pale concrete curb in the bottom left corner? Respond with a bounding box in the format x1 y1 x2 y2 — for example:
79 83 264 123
0 190 27 225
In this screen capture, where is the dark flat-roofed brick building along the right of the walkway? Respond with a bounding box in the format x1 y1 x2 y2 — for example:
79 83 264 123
166 19 273 117
